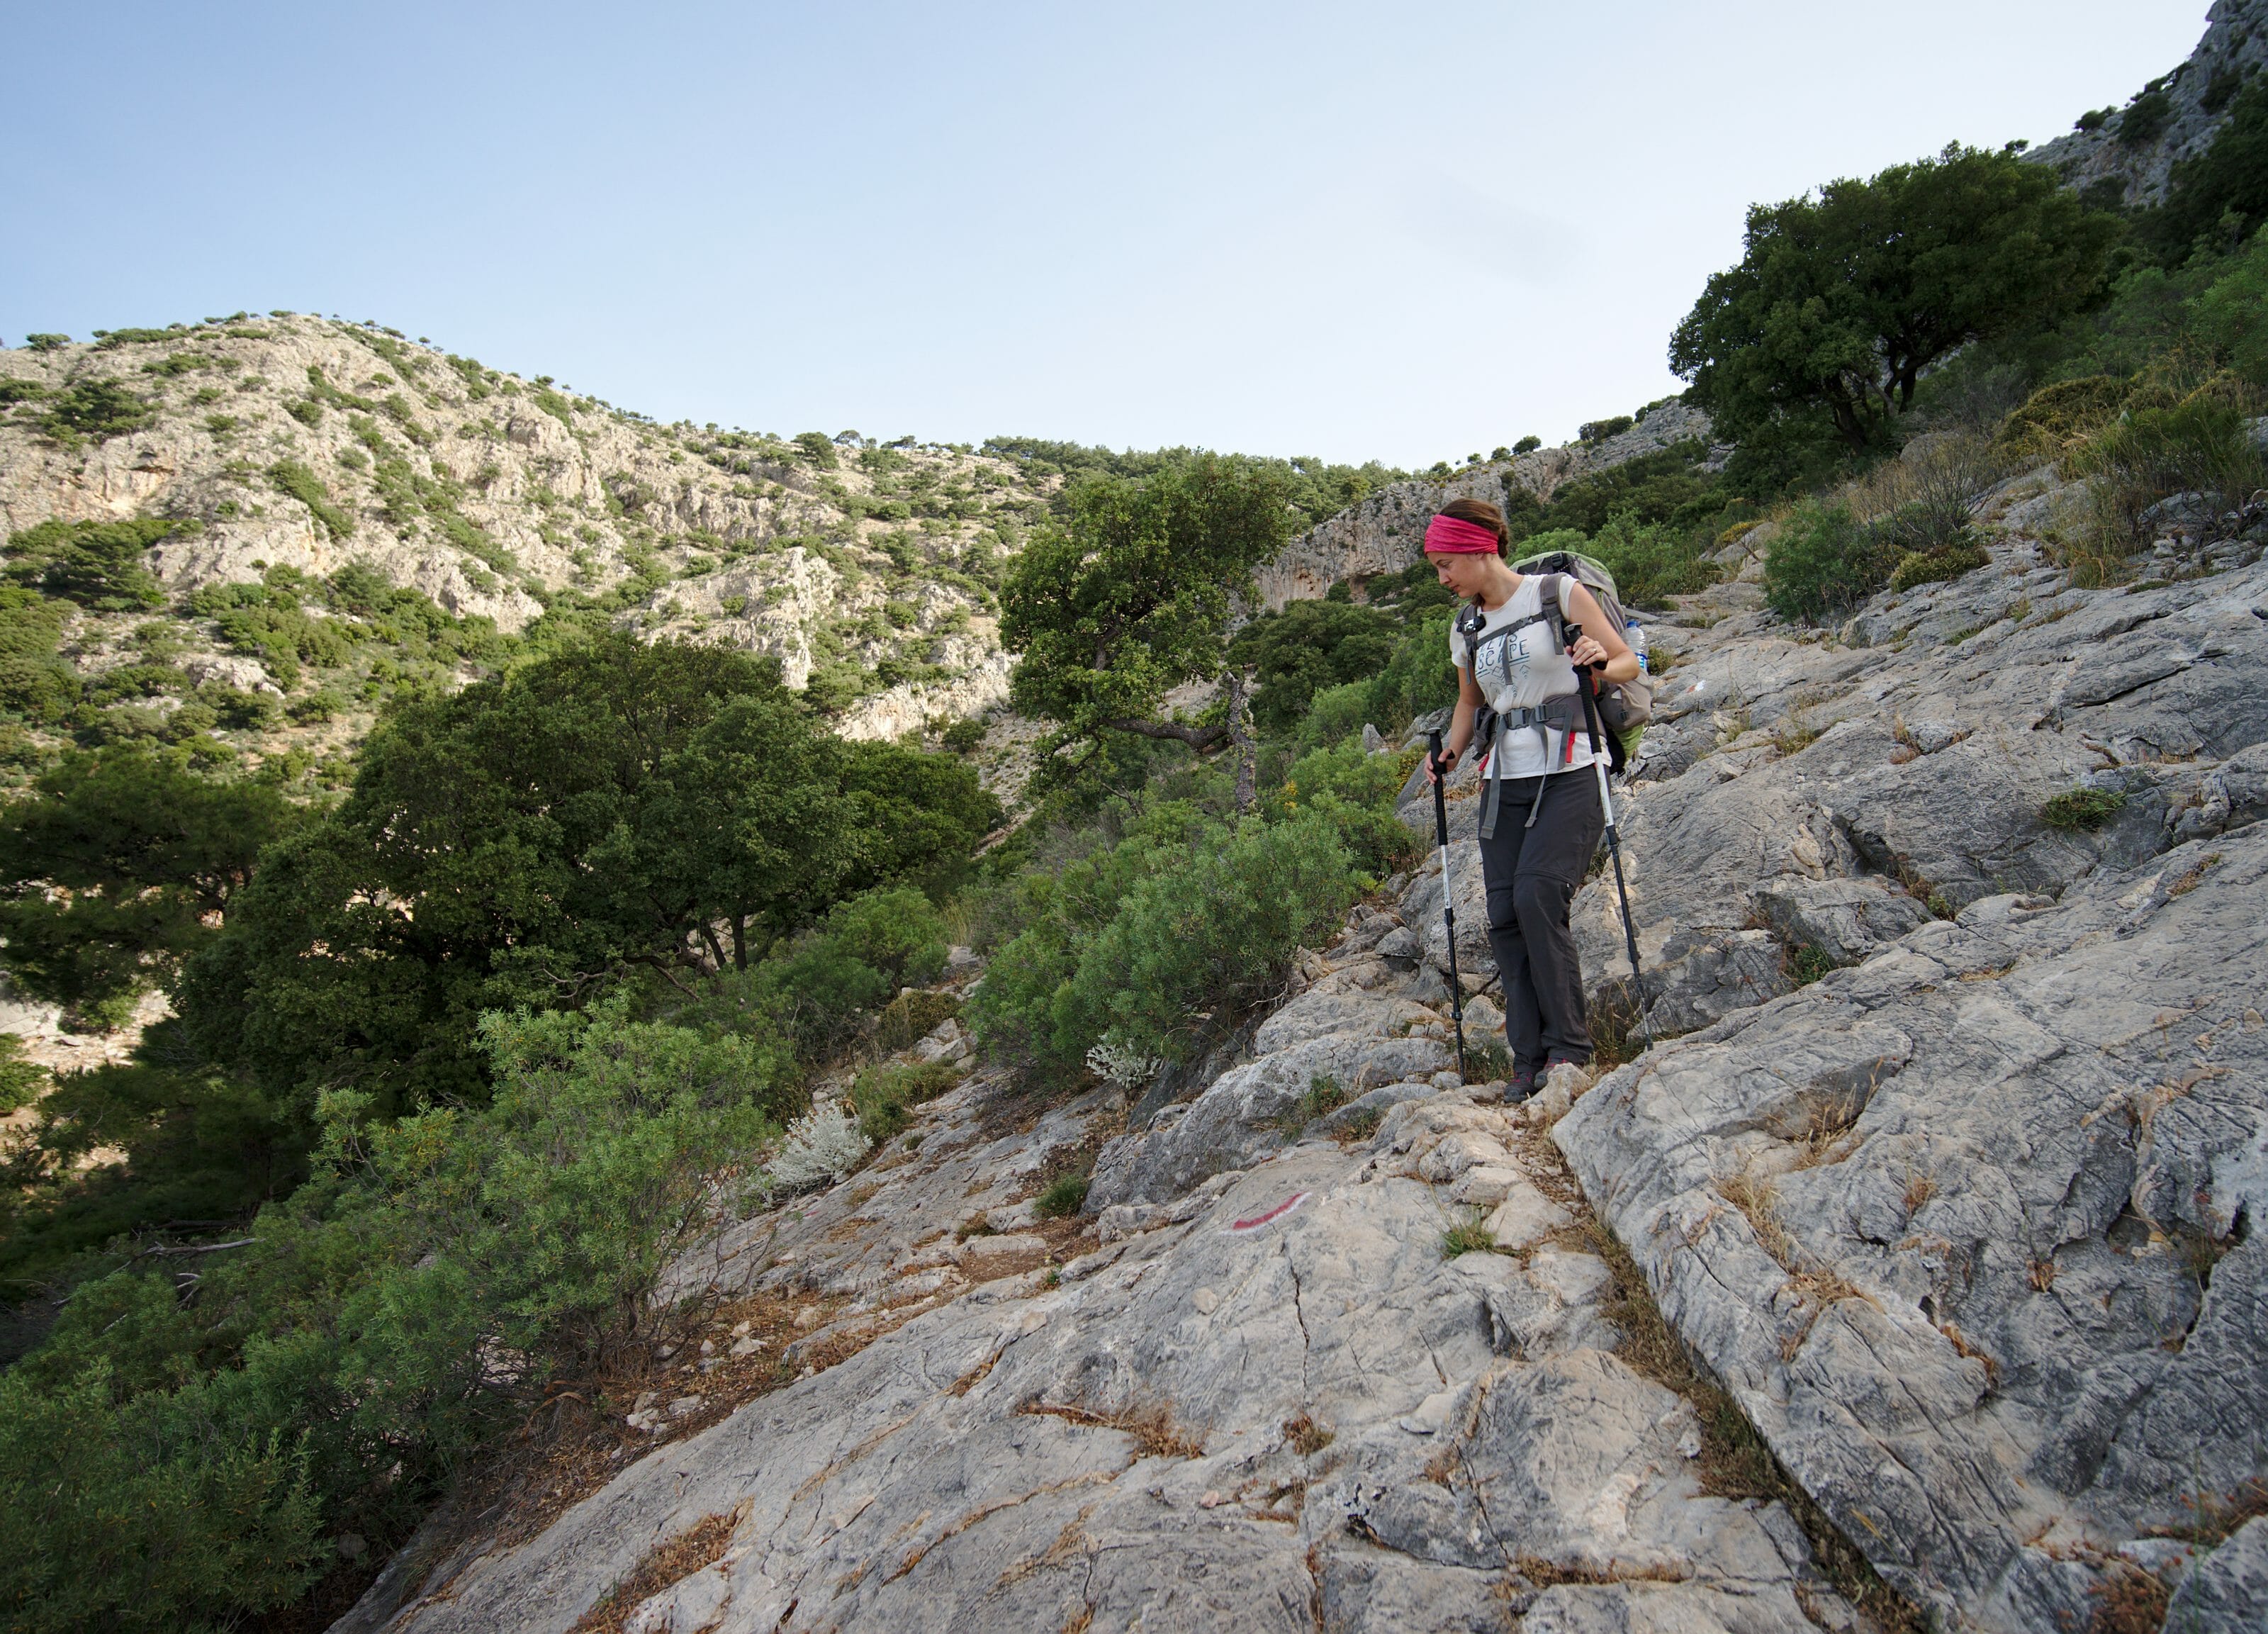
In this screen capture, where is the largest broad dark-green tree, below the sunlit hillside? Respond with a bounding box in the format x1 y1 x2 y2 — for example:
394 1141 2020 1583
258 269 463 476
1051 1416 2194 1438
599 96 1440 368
179 633 975 1112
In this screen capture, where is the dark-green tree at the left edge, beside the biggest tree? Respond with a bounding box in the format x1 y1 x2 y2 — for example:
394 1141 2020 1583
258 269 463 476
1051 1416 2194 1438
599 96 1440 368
0 746 297 1026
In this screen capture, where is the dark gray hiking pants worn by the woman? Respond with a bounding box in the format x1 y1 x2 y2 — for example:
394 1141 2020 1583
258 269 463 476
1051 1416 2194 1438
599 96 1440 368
1481 767 1606 1071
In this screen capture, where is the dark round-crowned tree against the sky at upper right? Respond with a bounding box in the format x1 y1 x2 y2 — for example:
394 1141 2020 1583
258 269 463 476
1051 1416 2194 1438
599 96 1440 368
1669 145 2121 449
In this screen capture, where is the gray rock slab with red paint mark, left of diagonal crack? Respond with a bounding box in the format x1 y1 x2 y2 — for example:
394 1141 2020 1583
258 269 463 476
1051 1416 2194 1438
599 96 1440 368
352 880 1860 1634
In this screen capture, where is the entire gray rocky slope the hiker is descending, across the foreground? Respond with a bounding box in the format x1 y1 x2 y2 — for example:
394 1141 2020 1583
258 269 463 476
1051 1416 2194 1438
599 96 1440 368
329 440 2268 1634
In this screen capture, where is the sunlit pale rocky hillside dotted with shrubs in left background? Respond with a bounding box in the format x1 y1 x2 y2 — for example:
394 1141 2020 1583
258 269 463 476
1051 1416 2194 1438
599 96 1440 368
0 315 1052 737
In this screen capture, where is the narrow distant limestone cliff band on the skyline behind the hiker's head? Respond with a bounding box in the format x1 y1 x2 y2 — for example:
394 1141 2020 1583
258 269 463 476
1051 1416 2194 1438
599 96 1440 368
1254 402 1731 612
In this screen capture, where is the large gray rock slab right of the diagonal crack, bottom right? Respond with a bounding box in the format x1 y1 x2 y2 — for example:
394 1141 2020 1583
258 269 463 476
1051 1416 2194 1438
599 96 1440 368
1556 826 2268 1630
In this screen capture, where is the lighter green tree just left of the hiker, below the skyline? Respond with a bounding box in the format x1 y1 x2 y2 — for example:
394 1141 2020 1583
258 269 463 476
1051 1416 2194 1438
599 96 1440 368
1000 454 1291 771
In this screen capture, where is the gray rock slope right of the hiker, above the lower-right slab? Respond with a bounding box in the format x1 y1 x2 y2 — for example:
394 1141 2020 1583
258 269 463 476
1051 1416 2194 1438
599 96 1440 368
1542 472 2268 1035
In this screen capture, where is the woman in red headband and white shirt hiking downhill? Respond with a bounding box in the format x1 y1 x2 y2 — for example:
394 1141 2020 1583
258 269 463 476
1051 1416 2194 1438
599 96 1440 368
1425 499 1637 1101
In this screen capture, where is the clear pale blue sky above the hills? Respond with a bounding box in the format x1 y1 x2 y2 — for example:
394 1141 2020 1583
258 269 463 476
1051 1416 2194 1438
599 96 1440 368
0 0 2204 465
